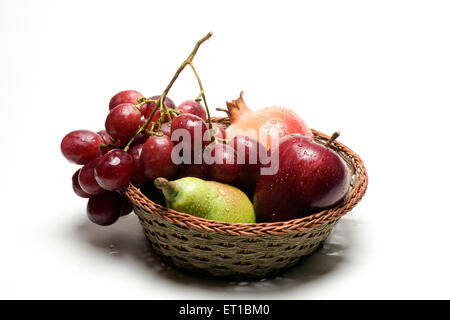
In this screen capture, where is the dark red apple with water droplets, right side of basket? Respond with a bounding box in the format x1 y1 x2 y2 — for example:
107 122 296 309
253 134 350 222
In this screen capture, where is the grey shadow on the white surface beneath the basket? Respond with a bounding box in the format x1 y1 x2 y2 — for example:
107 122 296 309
75 214 364 293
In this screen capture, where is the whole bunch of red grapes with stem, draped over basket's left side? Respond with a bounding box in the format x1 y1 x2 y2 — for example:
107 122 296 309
61 33 264 225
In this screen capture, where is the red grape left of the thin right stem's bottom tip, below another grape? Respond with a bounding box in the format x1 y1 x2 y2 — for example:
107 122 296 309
171 113 211 152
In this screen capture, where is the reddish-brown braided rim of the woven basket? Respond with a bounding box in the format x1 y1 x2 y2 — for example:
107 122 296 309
122 125 368 236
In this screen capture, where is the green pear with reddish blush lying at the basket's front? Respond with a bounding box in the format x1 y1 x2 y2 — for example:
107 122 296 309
154 177 256 223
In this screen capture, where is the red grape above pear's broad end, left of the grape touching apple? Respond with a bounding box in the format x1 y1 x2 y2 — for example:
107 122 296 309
204 142 239 182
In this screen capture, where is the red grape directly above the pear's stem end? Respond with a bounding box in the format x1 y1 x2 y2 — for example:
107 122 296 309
140 135 177 180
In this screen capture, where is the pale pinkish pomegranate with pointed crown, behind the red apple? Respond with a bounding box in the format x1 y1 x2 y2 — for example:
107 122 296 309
226 92 313 150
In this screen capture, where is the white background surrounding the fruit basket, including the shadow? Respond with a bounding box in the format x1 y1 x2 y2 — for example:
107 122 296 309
0 0 450 299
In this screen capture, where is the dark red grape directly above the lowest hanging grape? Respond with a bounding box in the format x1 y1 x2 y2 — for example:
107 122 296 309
94 149 134 191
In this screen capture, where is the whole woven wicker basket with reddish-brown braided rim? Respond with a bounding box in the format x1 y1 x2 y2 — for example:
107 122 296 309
123 118 368 279
